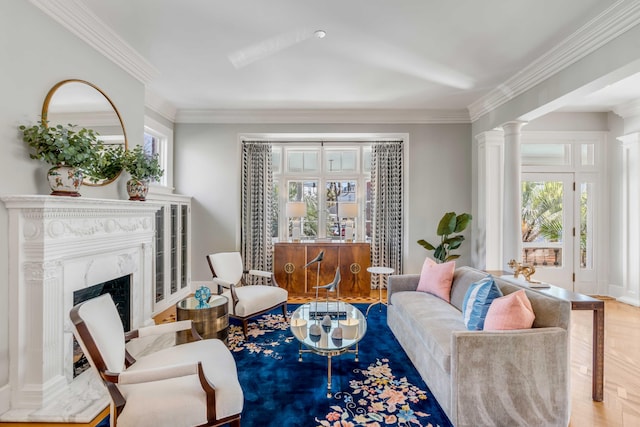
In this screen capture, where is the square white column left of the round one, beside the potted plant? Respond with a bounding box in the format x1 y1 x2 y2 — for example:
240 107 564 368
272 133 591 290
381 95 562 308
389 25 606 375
472 130 504 270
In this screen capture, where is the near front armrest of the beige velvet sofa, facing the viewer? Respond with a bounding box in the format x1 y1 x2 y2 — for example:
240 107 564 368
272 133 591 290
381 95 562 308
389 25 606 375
451 327 571 426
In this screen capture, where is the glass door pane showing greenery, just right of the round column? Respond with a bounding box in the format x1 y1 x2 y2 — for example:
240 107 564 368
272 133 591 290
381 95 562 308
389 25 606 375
521 173 574 290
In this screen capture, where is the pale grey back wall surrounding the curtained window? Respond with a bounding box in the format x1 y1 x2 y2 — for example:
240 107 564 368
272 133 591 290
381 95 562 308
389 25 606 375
174 124 472 281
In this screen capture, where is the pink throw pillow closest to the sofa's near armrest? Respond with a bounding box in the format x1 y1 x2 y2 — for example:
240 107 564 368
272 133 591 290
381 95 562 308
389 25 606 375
484 289 536 331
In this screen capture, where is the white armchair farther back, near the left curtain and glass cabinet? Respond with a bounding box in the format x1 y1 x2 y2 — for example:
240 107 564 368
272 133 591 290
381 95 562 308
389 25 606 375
207 252 289 340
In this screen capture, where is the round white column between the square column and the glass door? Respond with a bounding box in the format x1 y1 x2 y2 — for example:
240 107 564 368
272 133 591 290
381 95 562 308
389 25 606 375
501 121 526 270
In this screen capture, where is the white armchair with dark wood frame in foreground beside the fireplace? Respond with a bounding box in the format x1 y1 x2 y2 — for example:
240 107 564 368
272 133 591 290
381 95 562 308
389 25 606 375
70 294 244 427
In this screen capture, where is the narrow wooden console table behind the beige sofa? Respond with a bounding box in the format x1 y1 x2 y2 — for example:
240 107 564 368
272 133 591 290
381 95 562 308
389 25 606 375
487 271 604 402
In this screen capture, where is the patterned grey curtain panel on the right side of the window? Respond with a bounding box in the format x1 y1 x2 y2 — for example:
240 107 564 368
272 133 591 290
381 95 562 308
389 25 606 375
371 141 404 274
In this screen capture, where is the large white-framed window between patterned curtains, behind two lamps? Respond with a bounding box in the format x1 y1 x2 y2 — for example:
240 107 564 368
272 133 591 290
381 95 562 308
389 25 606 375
272 143 371 241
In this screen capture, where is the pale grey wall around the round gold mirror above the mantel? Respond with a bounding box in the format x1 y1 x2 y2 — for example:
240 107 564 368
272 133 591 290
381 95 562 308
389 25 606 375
0 0 144 413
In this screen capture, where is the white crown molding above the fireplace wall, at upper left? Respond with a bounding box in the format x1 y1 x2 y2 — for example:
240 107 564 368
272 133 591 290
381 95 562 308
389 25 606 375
29 0 160 84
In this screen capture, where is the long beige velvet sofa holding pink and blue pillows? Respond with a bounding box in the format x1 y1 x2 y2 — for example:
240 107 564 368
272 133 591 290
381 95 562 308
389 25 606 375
387 267 571 427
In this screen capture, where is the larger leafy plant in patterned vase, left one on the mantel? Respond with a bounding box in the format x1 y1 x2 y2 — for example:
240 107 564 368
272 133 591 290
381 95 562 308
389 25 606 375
18 120 102 197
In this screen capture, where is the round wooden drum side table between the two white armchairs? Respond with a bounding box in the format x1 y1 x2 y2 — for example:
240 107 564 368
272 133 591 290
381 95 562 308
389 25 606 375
176 295 229 344
